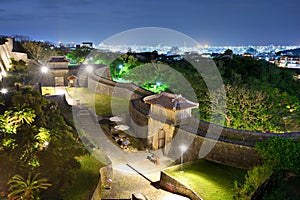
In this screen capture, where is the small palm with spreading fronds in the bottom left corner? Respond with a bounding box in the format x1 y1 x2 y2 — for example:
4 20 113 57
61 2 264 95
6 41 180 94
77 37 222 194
8 173 52 200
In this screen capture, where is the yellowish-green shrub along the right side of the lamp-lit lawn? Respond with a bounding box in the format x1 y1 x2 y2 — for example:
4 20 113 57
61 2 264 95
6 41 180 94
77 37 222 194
234 165 272 200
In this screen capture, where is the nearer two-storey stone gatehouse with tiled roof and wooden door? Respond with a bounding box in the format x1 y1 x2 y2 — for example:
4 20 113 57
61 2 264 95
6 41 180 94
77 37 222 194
143 92 199 153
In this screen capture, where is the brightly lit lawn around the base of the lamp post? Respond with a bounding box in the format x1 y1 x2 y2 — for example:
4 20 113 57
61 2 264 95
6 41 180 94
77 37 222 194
165 160 246 200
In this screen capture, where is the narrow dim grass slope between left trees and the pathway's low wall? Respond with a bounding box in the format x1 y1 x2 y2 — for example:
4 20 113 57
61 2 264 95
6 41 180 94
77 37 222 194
64 155 103 200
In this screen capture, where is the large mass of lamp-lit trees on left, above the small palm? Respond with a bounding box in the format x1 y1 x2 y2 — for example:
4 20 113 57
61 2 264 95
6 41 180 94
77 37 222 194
0 88 85 198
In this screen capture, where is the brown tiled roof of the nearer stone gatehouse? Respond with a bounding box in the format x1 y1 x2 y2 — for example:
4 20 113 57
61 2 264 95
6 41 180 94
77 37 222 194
144 92 199 110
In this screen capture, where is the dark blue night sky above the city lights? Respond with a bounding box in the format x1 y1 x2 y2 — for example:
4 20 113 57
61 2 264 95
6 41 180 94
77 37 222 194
0 0 300 45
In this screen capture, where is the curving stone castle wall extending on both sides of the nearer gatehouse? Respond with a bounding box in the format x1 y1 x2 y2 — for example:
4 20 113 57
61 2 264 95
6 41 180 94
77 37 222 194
88 68 300 169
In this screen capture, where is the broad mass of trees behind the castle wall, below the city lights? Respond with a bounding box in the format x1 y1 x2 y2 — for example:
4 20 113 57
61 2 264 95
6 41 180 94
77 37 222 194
98 49 300 133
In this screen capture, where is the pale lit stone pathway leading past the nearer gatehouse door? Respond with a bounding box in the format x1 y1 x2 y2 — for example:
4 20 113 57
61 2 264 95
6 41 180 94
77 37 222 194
73 97 188 200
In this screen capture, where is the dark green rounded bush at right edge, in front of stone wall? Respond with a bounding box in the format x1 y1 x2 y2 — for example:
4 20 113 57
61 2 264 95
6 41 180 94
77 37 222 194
256 137 300 175
